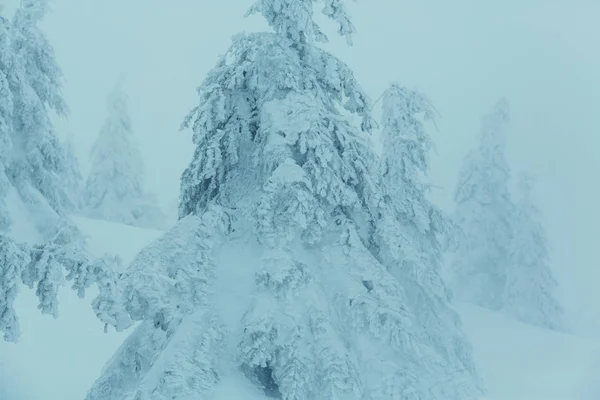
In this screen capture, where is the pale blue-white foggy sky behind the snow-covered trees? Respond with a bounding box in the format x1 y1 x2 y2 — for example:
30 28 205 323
3 0 600 328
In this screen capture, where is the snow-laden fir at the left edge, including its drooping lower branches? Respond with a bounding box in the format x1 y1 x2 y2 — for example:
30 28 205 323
0 0 118 341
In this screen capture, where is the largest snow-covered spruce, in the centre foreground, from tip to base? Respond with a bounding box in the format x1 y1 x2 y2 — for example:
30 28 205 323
88 0 479 400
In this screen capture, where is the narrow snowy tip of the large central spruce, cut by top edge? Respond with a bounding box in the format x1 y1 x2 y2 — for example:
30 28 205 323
247 0 355 44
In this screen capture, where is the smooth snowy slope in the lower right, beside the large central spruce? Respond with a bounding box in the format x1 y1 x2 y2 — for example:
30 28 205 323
457 304 600 400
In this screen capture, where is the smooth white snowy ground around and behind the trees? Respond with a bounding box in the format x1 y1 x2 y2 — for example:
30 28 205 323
0 218 600 400
